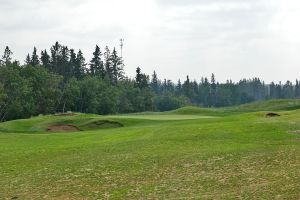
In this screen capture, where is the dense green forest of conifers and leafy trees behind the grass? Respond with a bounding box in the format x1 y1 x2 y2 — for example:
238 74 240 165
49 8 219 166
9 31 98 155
0 42 300 121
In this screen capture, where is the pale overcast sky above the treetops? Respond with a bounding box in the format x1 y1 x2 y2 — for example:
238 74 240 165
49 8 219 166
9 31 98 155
0 0 300 82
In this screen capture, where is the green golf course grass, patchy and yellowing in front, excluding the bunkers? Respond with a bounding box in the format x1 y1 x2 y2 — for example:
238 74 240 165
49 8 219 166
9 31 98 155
0 101 300 199
